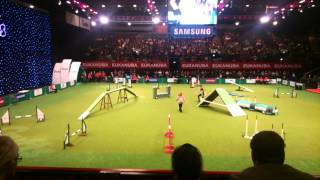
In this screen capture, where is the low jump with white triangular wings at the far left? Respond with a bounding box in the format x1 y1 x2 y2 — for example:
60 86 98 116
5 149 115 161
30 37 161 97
1 106 45 124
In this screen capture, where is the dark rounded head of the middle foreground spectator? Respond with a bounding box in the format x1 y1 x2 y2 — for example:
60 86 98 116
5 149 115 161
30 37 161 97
171 143 202 180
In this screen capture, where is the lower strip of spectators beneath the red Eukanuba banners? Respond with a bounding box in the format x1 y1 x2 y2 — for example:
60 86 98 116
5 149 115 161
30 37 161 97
82 69 301 82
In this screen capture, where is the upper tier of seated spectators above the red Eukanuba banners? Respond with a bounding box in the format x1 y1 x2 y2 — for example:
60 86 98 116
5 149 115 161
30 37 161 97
85 30 308 61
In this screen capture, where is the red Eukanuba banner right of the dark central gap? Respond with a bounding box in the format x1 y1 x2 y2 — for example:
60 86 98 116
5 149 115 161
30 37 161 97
180 62 303 69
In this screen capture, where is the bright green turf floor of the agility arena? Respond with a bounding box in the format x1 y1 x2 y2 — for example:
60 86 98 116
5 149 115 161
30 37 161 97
0 83 320 175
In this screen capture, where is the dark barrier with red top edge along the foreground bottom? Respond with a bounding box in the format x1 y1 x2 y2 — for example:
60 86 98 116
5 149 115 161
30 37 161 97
16 167 320 180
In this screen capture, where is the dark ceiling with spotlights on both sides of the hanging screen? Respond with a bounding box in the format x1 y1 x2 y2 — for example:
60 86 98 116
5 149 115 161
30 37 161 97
13 0 319 25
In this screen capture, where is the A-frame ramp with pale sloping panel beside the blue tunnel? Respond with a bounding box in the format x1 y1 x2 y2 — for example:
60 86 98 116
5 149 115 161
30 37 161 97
197 88 246 117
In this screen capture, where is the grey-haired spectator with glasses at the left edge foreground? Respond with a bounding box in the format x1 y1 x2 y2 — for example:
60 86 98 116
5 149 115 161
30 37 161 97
0 136 19 180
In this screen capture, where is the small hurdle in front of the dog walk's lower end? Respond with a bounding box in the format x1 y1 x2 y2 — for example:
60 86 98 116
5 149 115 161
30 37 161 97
63 120 87 149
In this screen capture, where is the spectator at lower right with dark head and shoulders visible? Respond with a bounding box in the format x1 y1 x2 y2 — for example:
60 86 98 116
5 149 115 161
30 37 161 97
231 131 315 180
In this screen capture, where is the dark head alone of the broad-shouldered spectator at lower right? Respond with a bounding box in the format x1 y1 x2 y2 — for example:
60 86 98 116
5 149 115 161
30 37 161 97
250 131 285 165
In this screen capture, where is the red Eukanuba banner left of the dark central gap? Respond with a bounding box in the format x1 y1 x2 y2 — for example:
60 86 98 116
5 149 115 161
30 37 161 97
82 61 169 69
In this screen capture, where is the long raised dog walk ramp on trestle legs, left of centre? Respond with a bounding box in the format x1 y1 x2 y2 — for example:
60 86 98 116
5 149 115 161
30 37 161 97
78 87 137 120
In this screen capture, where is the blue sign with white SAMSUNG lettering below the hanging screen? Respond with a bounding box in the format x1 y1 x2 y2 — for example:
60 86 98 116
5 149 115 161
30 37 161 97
169 25 214 38
